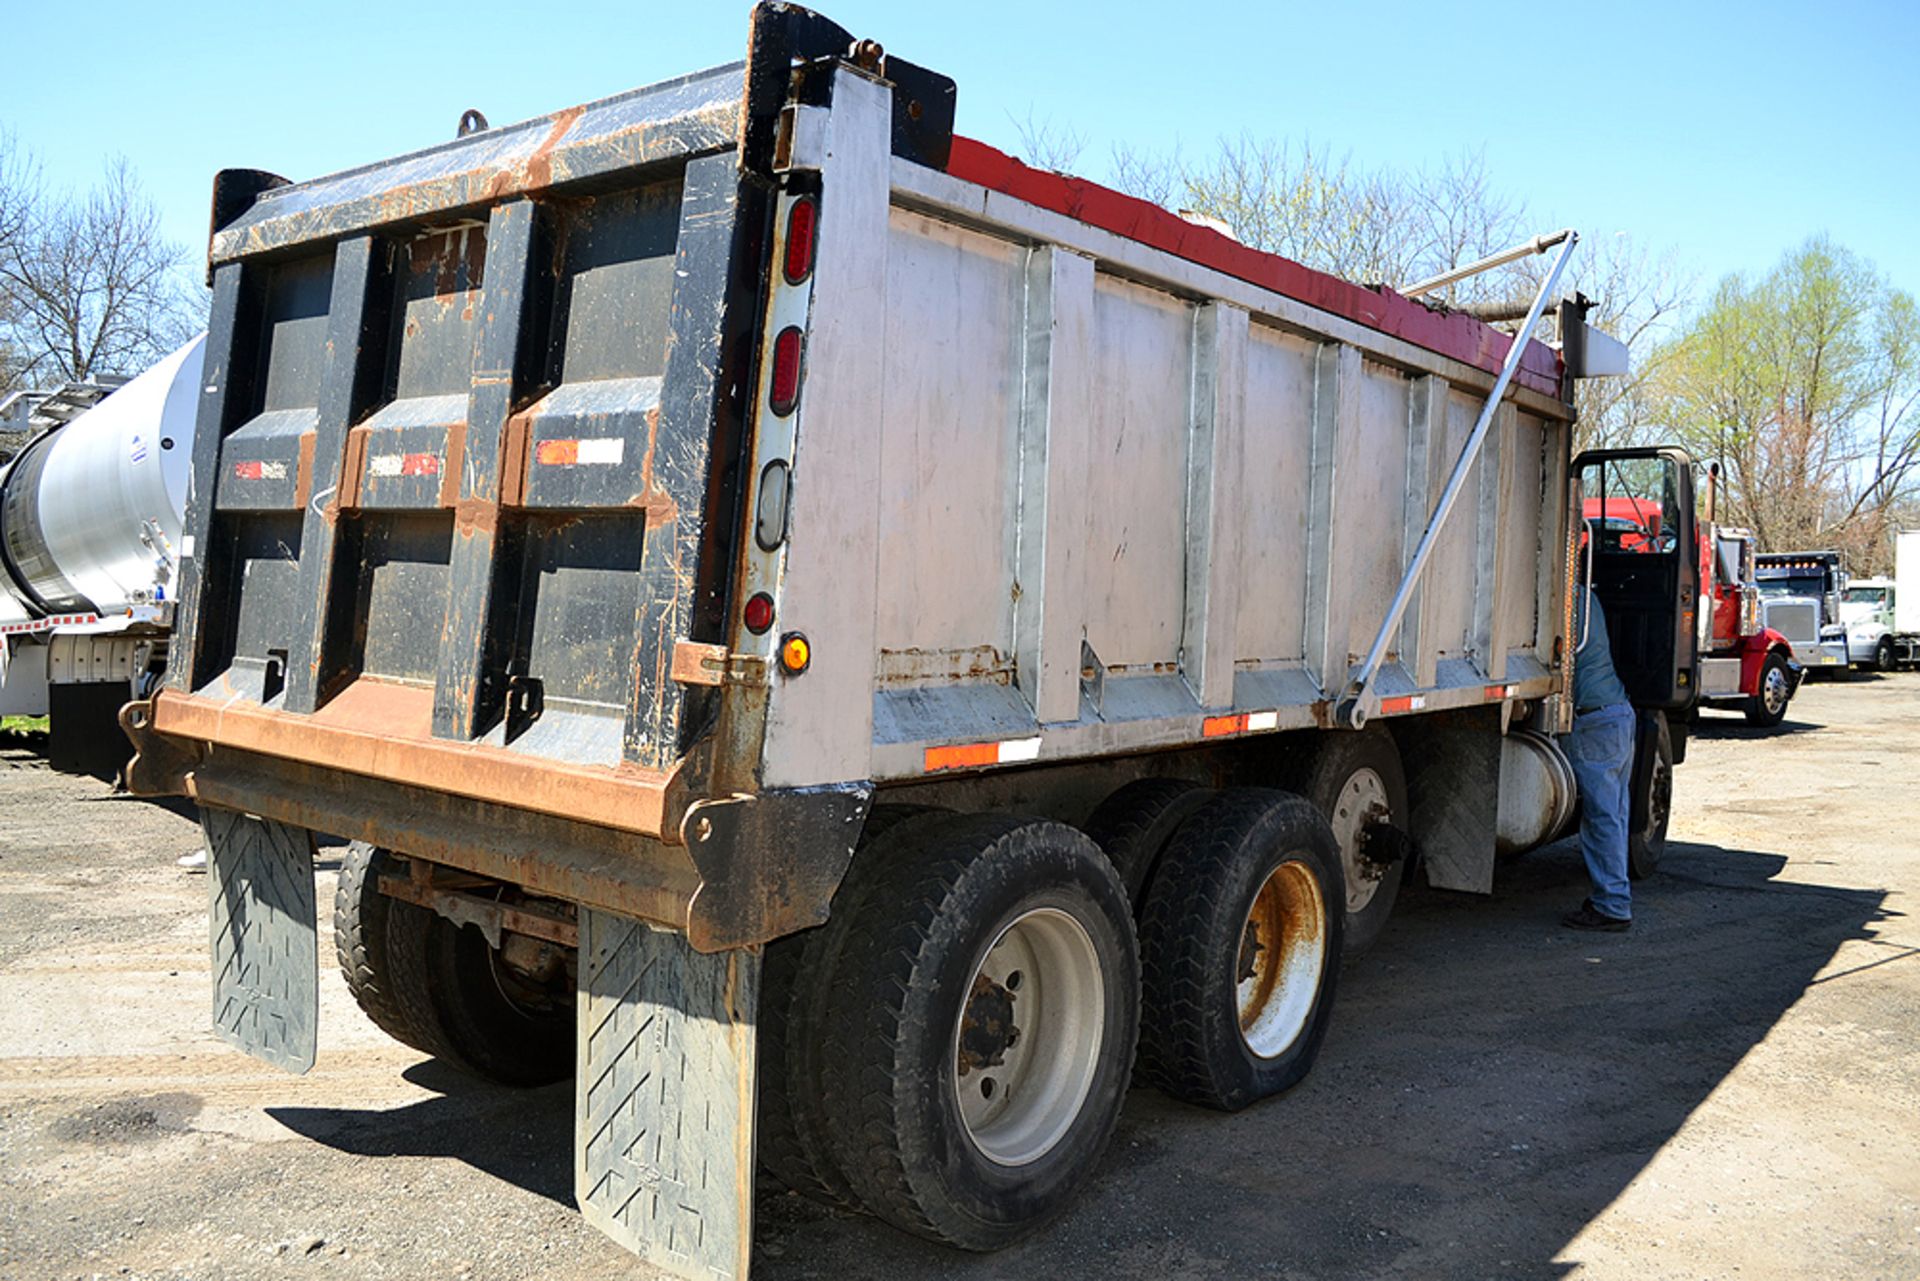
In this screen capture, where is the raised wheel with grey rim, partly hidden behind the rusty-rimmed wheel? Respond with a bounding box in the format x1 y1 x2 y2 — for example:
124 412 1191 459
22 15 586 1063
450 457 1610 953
1277 724 1407 956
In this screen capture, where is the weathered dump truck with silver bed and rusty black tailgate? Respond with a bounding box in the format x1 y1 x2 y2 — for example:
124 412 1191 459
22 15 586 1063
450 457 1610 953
121 4 1699 1277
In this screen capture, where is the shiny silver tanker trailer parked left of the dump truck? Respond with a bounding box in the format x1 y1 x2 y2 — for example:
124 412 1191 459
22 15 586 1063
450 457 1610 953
0 336 204 778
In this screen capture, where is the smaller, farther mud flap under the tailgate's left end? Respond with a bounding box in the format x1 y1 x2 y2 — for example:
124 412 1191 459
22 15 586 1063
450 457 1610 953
200 809 321 1072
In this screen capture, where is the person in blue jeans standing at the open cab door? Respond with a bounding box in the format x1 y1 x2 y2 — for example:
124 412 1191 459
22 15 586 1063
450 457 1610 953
1561 588 1634 933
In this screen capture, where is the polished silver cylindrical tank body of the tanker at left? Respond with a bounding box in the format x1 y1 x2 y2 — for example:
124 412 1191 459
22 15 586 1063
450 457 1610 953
0 336 204 622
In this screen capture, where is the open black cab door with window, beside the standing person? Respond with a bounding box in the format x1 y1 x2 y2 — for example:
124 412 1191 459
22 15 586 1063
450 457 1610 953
1574 446 1701 713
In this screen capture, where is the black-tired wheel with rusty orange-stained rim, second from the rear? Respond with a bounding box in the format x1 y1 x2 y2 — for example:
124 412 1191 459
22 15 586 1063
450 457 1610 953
1140 787 1346 1112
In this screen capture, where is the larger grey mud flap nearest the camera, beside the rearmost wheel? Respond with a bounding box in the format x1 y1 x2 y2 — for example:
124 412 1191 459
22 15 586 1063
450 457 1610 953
574 908 760 1281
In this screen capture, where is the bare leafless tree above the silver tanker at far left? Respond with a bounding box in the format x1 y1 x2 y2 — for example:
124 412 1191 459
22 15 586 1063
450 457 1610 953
0 156 198 382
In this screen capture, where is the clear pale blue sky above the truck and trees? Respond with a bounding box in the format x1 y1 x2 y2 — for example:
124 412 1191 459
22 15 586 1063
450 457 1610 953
0 0 1920 307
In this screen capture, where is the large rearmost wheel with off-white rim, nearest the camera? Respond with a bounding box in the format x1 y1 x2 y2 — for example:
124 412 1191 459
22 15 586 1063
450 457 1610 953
824 814 1139 1250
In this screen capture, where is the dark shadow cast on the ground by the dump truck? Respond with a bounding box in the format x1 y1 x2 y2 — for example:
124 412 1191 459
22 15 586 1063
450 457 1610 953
271 841 1885 1281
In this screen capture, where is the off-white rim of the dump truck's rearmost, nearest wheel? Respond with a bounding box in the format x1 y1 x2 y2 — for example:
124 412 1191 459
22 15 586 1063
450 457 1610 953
954 908 1106 1166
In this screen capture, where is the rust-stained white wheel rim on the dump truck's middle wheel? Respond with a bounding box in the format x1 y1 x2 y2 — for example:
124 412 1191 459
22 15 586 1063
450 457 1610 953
1235 858 1327 1058
